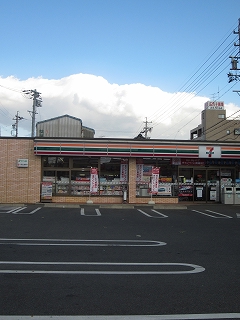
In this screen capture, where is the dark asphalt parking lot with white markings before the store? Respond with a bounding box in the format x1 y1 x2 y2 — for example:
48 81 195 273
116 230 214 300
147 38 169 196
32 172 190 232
0 204 240 319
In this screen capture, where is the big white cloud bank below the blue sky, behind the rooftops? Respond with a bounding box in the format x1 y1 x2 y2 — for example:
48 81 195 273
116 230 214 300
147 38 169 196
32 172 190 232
0 74 238 139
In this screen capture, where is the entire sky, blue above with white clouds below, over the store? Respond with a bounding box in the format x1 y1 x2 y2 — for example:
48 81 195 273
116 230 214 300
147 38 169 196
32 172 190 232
0 0 240 139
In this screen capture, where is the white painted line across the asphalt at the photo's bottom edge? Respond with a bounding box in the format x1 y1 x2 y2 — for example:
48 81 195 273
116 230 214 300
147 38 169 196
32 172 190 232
0 313 240 320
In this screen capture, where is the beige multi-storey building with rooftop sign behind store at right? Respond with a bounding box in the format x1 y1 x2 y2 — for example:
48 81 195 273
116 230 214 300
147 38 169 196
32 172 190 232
190 101 240 141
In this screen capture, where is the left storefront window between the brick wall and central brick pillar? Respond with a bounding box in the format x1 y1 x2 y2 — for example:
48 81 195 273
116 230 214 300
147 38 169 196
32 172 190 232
42 157 125 196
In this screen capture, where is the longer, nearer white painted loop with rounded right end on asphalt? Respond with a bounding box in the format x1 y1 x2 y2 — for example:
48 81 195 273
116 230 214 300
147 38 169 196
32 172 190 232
0 261 205 275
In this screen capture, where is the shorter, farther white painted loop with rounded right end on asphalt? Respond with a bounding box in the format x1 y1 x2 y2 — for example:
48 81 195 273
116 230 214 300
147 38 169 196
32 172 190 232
0 238 166 247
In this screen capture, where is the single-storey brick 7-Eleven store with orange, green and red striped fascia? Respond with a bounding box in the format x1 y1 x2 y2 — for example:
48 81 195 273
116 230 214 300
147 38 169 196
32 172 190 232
0 137 240 204
